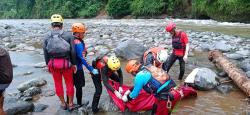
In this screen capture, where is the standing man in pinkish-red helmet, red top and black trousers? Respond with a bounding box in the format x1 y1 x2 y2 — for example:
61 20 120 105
164 22 189 81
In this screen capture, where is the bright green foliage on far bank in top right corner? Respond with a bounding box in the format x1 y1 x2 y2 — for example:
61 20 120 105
193 0 250 21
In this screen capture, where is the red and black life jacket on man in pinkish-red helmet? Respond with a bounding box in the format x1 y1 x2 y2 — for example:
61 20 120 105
172 31 186 50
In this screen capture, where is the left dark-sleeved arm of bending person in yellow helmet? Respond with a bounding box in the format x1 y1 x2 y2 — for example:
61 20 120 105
101 66 115 92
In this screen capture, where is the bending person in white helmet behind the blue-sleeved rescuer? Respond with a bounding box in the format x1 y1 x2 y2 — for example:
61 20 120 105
142 47 168 70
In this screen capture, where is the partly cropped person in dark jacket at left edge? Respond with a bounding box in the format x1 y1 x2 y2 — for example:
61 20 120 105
0 47 13 115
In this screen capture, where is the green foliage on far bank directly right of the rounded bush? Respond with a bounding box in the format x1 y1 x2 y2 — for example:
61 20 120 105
131 0 165 16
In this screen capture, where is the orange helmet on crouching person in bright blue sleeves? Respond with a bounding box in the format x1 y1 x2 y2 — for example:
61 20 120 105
125 60 141 73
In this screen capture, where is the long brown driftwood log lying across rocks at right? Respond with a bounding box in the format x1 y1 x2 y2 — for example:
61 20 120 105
208 50 250 97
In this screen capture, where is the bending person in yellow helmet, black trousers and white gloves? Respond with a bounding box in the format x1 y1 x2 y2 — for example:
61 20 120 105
92 56 123 113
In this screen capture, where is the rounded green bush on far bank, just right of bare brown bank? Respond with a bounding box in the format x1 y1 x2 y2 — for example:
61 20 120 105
106 0 131 18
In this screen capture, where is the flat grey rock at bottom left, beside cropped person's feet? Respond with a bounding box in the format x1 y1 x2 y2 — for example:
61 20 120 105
4 98 34 115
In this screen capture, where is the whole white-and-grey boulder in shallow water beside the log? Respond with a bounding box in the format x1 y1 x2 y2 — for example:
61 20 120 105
185 68 218 90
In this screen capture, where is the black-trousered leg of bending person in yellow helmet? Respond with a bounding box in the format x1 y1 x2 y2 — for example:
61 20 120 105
91 71 102 113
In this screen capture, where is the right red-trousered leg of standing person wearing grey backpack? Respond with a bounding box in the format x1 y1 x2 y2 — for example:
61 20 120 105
62 68 74 110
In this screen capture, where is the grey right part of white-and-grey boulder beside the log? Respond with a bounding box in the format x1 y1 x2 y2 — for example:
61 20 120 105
194 68 218 90
